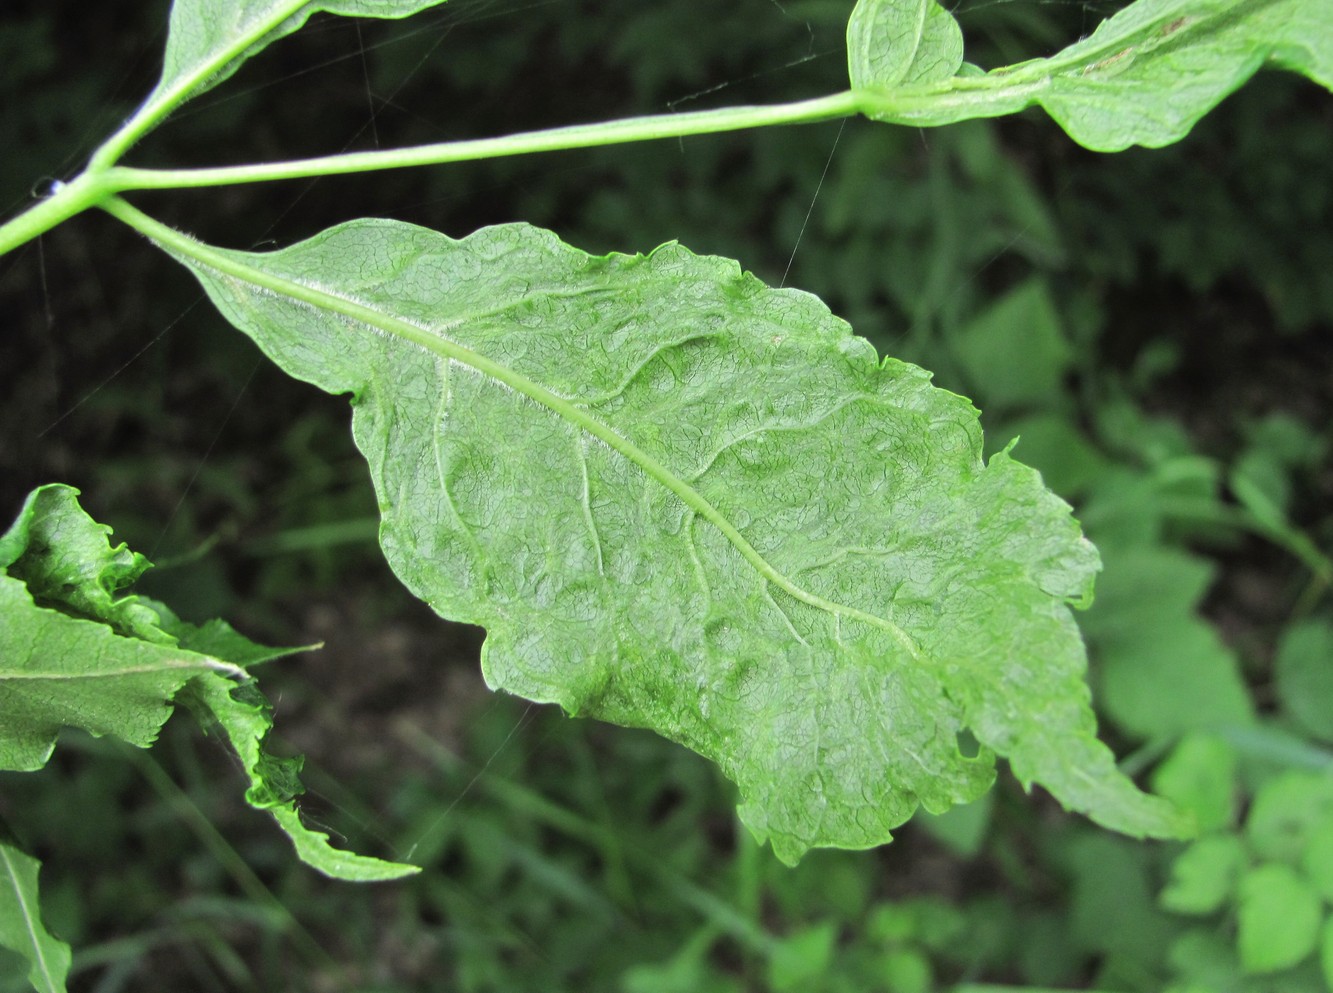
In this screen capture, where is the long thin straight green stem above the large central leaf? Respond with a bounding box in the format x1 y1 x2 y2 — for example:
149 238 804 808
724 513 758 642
104 91 861 191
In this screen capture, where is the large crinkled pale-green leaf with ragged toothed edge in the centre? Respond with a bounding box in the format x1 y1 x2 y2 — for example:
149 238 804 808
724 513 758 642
132 204 1188 861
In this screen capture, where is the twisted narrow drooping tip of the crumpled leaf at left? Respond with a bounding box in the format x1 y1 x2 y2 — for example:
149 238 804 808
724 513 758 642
185 673 420 882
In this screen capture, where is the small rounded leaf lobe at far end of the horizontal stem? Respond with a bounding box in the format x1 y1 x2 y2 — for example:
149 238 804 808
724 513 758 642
846 0 962 89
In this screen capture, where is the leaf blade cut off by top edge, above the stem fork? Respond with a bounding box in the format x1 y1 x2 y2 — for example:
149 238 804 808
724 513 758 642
149 0 444 119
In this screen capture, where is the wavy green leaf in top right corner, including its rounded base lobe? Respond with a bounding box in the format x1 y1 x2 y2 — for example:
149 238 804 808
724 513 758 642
848 0 1333 152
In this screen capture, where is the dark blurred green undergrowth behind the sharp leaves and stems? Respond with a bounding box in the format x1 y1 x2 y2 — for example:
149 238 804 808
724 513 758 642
0 0 1333 993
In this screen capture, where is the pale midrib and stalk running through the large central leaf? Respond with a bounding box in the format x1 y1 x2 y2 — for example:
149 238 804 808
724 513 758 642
107 200 922 657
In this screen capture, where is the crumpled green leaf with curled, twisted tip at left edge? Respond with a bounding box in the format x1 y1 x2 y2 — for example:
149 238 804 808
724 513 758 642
0 484 417 879
